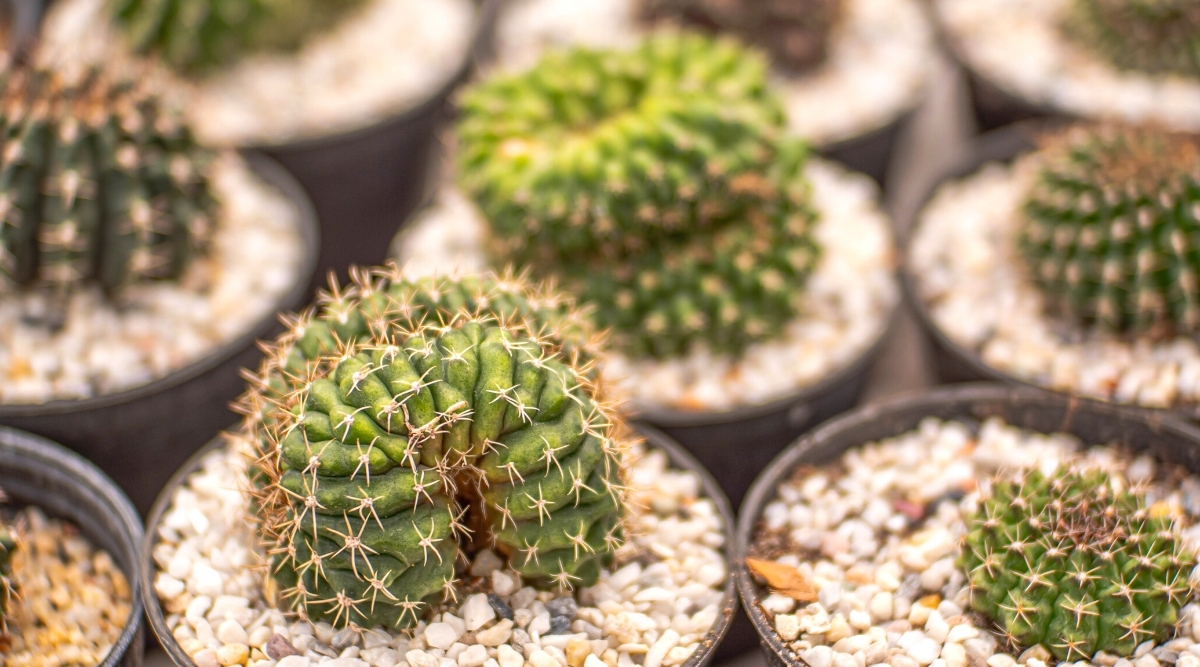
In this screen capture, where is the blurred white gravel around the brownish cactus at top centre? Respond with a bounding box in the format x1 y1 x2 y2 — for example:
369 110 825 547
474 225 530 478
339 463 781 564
482 0 935 146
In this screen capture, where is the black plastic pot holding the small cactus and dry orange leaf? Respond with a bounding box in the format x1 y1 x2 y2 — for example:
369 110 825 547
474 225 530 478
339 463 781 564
734 384 1200 667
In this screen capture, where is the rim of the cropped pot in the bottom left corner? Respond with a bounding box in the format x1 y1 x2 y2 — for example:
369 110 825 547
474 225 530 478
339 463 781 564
0 426 144 667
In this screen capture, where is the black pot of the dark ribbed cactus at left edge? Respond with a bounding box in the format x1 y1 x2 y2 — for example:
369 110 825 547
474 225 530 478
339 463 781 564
0 154 319 512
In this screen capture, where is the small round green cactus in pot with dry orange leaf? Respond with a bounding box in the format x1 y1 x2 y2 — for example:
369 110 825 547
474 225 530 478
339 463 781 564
959 468 1195 661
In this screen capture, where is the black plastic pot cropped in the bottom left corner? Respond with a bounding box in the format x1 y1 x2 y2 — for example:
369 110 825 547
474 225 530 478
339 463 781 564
0 427 145 667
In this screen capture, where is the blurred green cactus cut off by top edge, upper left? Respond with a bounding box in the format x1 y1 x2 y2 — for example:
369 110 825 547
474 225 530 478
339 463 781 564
108 0 366 74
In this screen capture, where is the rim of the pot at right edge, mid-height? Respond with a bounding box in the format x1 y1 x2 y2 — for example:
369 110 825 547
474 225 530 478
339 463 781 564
900 118 1200 419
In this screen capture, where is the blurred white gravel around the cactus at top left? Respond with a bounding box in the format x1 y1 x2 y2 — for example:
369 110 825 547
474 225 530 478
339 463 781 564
34 0 475 146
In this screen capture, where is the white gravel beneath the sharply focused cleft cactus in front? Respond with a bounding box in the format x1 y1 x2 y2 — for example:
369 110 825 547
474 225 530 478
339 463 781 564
152 445 727 667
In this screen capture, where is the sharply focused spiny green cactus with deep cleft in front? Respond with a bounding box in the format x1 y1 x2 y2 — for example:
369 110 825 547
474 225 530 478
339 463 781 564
241 266 623 627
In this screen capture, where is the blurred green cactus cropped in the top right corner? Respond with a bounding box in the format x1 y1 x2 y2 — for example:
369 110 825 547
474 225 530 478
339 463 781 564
1064 0 1200 78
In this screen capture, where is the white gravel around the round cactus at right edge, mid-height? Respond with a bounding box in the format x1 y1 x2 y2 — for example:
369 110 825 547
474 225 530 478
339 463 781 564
908 157 1200 408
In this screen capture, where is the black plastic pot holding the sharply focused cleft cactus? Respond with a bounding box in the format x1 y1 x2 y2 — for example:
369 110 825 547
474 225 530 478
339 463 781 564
142 427 738 667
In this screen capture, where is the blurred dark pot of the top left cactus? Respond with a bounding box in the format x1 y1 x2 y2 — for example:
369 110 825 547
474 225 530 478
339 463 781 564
257 0 502 281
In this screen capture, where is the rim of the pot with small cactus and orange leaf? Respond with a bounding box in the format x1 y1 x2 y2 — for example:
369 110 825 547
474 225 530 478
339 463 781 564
733 383 1200 667
